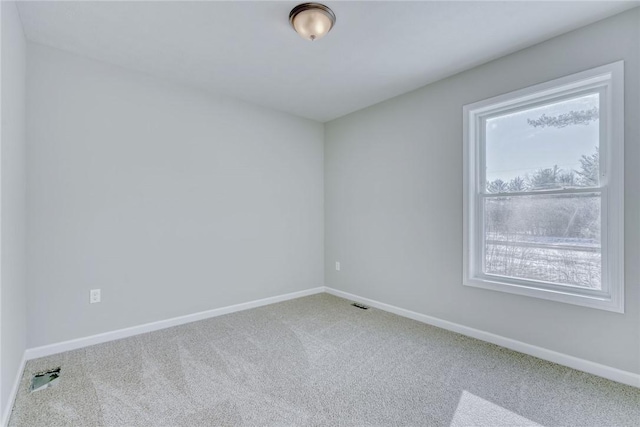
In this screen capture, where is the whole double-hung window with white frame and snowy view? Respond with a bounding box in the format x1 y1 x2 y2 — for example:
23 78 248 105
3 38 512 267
463 61 624 312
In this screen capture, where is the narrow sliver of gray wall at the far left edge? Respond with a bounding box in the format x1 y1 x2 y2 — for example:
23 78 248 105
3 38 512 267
0 1 27 416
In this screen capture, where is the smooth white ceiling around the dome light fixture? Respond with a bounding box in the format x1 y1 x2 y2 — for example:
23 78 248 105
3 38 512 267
18 0 640 122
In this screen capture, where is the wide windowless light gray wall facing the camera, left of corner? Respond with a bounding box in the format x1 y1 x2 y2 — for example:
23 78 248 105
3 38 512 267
27 44 324 347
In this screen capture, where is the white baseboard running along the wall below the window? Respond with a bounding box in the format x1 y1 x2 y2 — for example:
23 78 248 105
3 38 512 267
325 286 640 387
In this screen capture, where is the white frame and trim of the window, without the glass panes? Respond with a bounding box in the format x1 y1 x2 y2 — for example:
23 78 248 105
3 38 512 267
463 61 624 313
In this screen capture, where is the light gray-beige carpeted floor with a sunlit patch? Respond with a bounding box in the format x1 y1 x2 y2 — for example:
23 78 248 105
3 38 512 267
10 294 640 427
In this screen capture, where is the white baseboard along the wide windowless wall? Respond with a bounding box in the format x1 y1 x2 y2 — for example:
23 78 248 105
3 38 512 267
25 286 324 360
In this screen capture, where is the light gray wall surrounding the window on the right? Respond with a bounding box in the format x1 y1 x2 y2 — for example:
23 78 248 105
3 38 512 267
325 9 640 373
